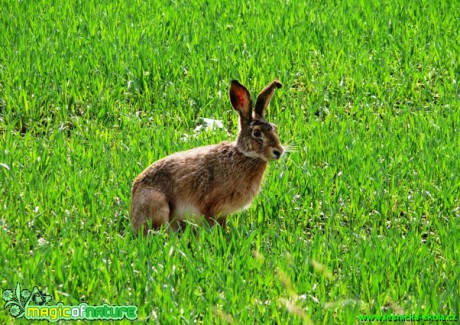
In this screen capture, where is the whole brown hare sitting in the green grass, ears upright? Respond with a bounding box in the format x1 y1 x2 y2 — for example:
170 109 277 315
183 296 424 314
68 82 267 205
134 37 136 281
131 80 284 234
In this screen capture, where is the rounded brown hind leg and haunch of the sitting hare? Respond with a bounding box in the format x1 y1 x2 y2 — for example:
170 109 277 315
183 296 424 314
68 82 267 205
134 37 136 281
131 188 170 235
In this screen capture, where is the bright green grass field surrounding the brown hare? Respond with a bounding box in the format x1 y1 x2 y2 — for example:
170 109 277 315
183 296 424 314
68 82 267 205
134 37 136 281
0 0 460 324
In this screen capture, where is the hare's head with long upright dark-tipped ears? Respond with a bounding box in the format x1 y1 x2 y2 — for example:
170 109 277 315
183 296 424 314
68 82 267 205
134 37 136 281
230 80 284 161
